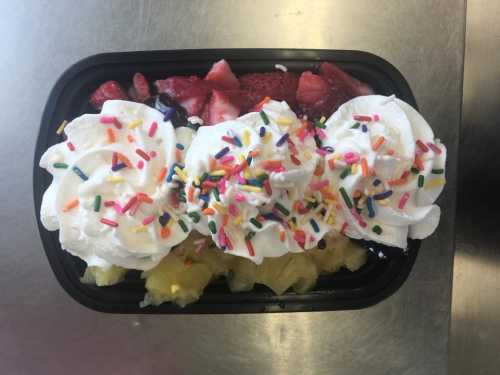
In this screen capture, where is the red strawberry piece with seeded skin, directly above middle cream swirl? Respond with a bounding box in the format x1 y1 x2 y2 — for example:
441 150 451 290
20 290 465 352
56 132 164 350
240 72 298 108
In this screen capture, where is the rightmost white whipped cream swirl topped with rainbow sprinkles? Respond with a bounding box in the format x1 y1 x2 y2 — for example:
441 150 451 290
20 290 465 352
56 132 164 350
324 95 446 248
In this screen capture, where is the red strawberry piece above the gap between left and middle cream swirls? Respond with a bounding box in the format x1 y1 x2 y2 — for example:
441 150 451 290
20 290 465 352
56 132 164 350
155 76 210 116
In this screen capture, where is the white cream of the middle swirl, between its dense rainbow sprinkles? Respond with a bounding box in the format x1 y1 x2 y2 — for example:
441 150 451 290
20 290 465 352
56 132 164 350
184 101 331 264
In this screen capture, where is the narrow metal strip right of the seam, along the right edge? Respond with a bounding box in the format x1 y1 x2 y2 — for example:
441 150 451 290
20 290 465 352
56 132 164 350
449 0 500 375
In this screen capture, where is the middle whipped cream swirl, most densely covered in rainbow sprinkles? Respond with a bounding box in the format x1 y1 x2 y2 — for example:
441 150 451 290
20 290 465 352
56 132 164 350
184 101 331 264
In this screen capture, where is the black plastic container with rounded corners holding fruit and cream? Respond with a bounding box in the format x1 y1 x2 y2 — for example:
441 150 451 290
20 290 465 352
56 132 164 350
33 49 420 314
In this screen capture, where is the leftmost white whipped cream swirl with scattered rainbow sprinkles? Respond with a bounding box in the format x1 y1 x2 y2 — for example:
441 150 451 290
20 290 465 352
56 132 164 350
40 100 192 270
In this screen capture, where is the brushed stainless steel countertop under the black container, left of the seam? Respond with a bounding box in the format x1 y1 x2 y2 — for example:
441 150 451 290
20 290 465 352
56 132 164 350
0 0 465 375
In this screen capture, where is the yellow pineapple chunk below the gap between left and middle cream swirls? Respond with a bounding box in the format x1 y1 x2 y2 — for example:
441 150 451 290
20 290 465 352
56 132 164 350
143 253 213 307
